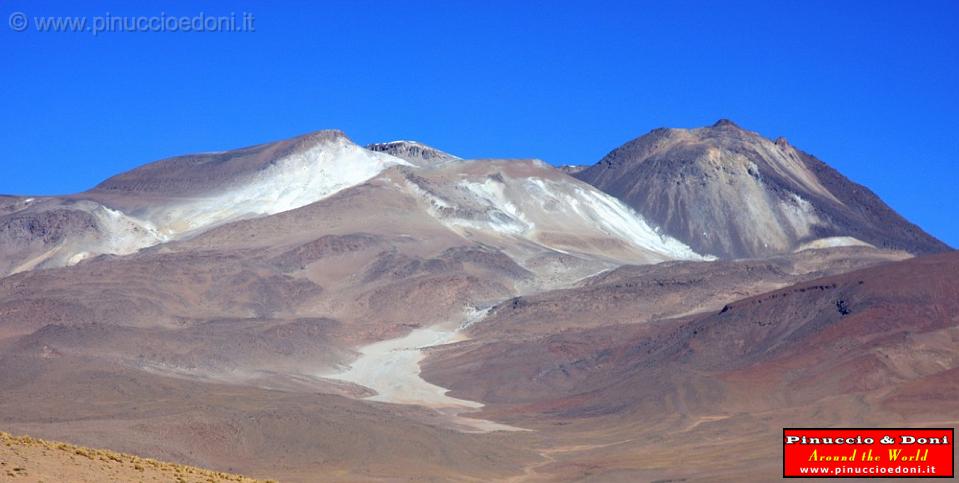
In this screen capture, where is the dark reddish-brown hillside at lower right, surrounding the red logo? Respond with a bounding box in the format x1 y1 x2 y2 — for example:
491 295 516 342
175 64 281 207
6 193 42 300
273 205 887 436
425 252 959 481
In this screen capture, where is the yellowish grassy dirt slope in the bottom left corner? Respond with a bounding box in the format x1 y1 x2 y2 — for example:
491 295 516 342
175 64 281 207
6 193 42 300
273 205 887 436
0 431 270 483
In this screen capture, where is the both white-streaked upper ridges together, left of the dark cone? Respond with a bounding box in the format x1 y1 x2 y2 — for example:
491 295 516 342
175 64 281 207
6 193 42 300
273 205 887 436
0 131 699 273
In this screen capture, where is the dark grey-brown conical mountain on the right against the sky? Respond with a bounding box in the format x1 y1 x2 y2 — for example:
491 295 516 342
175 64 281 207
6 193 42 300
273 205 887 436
572 120 949 258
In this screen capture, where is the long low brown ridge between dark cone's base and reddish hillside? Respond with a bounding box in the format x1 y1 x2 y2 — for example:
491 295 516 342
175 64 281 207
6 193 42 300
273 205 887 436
470 247 909 340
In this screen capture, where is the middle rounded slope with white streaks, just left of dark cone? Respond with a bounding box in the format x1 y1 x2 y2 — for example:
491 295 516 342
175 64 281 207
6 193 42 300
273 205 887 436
378 160 703 263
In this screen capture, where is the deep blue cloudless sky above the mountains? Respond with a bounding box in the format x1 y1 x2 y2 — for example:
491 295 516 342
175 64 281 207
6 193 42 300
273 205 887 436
0 0 959 246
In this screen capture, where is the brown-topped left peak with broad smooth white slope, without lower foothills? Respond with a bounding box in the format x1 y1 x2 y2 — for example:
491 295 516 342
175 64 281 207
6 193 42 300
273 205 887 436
81 131 408 236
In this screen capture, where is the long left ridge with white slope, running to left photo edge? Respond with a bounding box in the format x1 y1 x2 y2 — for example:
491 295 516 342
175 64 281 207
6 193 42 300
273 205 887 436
0 131 408 274
